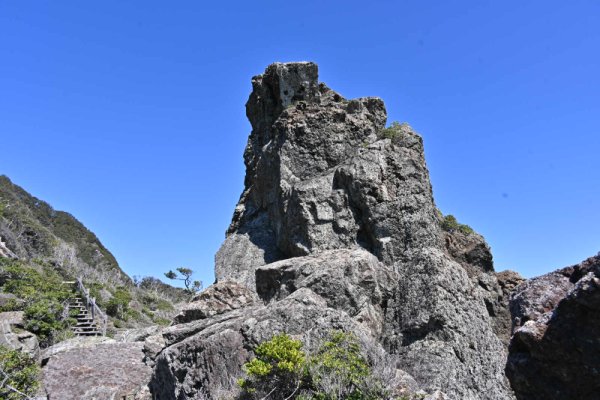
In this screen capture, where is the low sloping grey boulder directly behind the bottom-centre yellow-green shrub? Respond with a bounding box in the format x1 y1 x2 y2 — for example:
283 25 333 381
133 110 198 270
146 288 417 399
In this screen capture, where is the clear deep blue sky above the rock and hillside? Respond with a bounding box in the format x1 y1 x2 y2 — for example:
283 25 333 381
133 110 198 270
0 0 600 283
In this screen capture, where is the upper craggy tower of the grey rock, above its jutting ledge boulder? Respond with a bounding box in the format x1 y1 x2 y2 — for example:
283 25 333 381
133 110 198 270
216 63 440 287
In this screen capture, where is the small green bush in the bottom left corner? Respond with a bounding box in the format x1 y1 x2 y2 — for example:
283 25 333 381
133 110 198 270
0 346 39 400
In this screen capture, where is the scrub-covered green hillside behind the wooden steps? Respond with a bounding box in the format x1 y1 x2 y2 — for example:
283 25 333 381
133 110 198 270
0 176 189 344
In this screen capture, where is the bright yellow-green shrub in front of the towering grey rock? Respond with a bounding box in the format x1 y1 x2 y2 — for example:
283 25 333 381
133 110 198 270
238 331 386 400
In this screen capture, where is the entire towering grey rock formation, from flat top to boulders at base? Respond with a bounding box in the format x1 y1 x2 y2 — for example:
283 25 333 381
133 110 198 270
146 63 513 400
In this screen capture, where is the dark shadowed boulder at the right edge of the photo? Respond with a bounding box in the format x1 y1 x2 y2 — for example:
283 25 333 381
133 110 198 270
506 256 600 400
